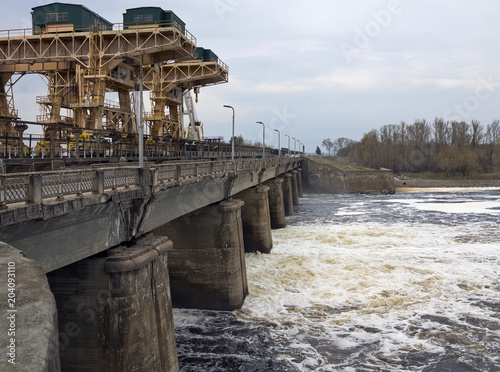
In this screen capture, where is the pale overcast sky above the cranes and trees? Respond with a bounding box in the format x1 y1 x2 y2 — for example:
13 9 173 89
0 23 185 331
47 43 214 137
0 0 500 152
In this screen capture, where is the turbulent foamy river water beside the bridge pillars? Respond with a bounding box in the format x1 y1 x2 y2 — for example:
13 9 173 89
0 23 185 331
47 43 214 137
175 189 500 372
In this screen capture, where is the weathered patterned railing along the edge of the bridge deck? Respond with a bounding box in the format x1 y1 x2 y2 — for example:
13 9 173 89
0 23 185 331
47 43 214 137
0 158 299 208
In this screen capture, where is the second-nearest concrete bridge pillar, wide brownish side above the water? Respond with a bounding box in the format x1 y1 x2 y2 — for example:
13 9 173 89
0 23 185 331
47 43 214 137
154 200 248 310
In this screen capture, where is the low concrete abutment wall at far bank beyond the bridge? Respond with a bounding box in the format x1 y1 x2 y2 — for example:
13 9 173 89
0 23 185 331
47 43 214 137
305 159 395 194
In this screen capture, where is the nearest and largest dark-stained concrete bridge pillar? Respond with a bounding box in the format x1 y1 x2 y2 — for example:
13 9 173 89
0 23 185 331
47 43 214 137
47 237 179 372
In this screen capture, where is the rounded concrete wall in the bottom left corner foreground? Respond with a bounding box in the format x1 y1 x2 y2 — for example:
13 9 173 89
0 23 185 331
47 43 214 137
0 242 60 372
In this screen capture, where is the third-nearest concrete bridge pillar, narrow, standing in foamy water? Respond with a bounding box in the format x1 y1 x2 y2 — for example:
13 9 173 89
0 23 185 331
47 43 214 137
236 185 273 253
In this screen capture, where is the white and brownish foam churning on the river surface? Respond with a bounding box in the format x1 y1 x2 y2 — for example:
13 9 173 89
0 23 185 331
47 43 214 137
236 212 500 371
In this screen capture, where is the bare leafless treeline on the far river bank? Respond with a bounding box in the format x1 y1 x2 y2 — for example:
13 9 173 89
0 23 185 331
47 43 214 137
322 118 500 175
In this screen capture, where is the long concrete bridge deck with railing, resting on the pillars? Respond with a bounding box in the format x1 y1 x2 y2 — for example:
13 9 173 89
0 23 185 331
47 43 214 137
0 158 302 272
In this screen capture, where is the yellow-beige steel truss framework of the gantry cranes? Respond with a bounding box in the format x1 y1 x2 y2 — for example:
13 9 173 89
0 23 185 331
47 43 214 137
0 24 228 154
